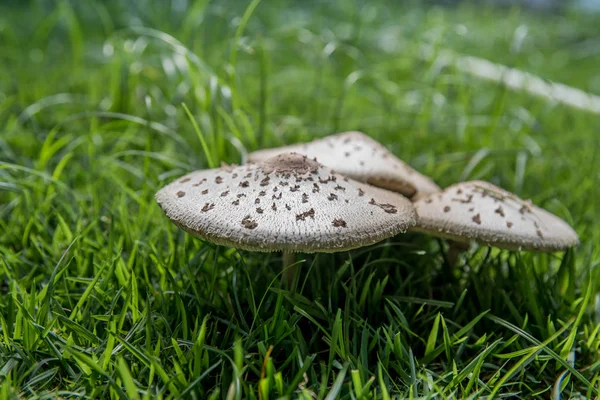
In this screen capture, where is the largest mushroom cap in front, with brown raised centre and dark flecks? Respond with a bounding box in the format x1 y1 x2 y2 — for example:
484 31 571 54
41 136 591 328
156 153 416 253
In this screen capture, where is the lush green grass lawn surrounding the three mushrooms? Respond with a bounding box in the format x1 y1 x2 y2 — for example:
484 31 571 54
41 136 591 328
0 0 600 399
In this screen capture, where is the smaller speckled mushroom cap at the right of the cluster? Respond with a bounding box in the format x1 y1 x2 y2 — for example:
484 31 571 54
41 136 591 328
412 181 579 251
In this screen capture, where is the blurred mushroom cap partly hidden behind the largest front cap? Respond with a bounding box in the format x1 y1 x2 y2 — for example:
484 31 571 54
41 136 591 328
248 132 440 197
